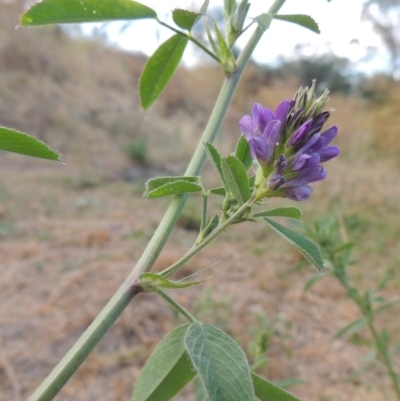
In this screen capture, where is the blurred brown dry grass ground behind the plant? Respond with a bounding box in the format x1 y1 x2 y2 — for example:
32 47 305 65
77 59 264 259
0 3 400 401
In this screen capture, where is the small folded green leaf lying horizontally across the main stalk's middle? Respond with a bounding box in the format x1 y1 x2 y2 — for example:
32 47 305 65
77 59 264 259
144 176 203 199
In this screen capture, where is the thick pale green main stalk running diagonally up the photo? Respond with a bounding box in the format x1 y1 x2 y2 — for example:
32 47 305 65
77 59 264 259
29 0 285 401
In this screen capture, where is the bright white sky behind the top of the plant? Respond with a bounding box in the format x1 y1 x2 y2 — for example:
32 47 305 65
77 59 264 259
98 0 387 72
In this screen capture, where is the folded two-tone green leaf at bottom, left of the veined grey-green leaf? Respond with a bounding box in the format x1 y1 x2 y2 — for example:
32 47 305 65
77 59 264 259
132 324 196 401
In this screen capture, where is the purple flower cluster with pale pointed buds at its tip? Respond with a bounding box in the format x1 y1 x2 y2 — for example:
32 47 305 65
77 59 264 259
239 83 339 201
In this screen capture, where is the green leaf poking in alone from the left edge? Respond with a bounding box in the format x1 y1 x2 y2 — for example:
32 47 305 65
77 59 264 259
0 127 60 161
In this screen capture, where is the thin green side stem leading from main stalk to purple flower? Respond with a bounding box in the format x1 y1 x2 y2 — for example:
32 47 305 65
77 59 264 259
160 197 254 278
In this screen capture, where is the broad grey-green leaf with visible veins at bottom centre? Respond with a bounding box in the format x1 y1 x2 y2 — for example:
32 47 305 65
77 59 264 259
184 322 254 401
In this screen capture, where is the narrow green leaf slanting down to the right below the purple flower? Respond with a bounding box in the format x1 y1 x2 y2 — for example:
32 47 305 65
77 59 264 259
263 217 324 269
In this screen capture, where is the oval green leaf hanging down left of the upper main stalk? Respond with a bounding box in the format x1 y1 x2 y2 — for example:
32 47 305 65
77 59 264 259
139 34 188 109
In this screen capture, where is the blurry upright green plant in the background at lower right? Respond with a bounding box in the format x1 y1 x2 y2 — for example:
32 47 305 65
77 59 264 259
305 214 400 400
